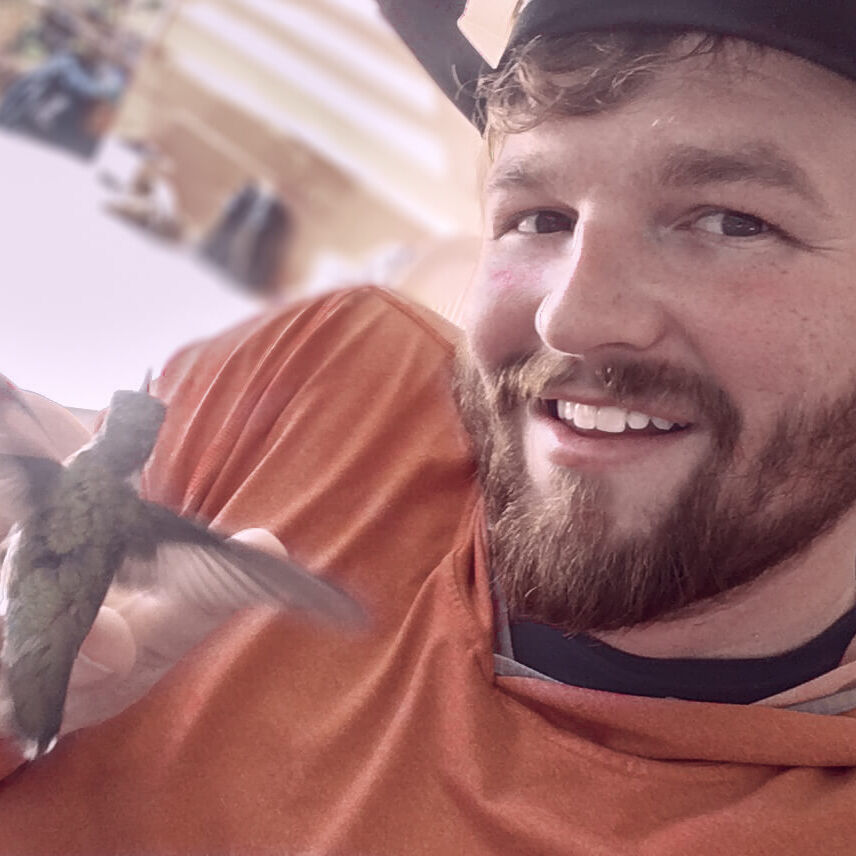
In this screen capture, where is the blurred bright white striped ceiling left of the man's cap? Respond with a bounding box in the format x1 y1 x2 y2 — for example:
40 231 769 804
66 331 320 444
155 0 488 234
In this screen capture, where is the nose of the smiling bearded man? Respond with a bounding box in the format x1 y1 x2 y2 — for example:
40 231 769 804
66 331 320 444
535 219 666 356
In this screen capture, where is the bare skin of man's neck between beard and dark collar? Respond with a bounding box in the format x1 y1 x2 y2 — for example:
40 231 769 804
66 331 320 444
592 520 856 658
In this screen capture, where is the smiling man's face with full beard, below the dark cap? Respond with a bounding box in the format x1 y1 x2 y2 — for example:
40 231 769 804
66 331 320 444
461 45 856 631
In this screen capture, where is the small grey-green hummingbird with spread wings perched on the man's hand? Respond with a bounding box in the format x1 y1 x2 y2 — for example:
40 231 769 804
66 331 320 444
0 378 363 759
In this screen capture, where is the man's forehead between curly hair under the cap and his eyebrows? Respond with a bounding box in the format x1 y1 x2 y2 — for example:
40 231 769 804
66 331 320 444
486 45 856 194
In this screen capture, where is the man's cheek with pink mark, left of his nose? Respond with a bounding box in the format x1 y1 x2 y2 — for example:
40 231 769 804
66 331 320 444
465 261 543 368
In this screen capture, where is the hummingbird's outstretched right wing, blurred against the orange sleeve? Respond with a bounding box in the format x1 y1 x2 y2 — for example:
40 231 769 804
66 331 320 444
117 502 365 625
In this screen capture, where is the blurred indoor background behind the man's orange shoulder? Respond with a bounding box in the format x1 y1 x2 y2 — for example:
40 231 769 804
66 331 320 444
0 0 508 419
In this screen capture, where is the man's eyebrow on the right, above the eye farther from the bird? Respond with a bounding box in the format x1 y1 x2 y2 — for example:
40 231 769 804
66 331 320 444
657 143 824 208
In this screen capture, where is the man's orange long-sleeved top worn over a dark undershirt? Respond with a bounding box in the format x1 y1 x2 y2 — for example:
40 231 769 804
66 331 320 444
0 289 856 856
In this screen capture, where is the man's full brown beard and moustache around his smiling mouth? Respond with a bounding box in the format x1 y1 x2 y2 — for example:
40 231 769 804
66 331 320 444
455 346 856 634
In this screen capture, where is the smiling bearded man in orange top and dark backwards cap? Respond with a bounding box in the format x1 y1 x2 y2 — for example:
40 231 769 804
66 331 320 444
0 0 856 856
